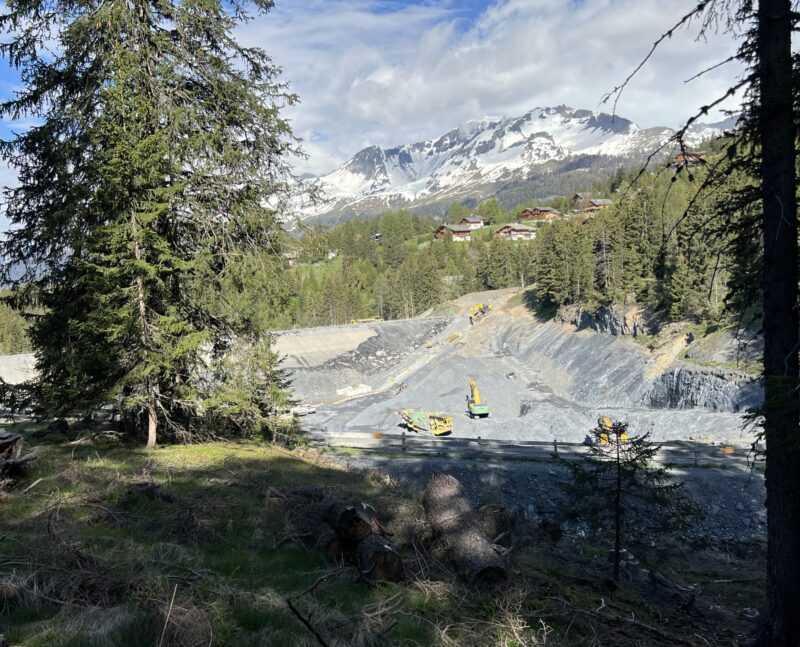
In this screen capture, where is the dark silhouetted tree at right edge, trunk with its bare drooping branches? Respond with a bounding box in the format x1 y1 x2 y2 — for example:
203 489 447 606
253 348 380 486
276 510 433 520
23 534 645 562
604 0 800 647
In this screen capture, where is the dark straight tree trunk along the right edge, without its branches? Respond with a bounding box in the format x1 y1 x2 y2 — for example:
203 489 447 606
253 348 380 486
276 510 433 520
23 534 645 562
757 0 800 647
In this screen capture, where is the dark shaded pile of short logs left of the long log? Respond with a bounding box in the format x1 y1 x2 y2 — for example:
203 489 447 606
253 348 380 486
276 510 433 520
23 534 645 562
273 488 403 582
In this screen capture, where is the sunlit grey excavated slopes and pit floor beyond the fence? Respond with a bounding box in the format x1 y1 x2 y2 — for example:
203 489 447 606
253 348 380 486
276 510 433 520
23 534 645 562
277 290 761 446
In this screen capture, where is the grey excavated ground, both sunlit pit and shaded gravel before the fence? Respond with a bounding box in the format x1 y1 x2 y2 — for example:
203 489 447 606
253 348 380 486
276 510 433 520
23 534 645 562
278 290 766 541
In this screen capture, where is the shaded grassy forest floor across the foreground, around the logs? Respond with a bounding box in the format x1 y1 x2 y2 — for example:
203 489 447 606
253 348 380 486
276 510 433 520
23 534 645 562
0 422 763 647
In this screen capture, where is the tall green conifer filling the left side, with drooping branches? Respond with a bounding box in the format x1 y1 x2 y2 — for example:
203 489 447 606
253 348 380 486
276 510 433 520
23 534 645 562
0 0 295 446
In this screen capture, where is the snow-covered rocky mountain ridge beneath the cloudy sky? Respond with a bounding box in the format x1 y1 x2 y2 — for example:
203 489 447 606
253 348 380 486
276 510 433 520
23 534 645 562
307 106 733 225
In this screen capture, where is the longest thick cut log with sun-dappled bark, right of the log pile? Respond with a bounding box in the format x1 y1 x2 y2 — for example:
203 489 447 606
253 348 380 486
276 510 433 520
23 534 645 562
422 474 507 587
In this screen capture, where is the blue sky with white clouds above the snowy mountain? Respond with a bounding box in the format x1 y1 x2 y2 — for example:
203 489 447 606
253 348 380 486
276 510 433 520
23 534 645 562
0 0 740 184
